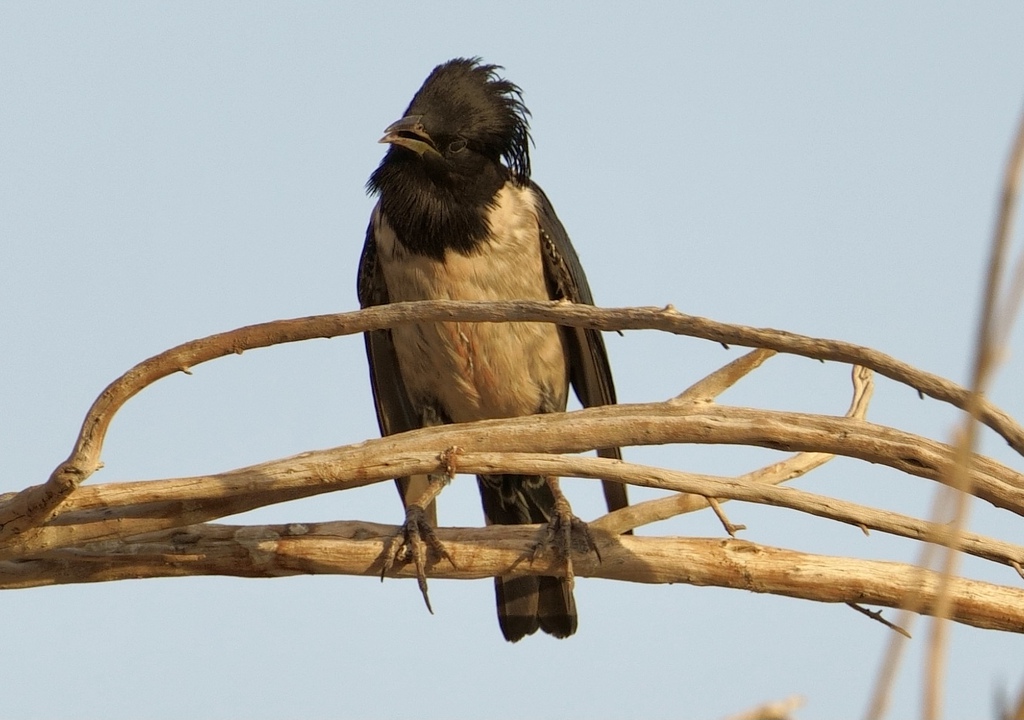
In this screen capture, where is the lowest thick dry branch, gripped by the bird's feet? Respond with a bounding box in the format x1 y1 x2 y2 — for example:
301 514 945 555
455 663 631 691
8 522 1024 632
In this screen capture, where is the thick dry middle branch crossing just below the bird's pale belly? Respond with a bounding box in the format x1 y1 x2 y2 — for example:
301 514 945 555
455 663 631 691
8 404 1024 561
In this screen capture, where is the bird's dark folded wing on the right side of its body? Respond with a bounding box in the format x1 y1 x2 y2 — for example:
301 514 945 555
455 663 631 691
530 182 629 510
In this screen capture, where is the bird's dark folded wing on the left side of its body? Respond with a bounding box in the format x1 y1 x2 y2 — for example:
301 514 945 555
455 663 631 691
356 210 437 525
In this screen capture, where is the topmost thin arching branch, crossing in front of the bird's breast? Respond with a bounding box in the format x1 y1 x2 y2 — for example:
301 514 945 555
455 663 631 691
6 301 1024 540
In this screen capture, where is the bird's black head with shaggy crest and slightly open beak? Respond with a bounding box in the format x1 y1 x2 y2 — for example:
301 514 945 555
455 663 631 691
371 57 529 189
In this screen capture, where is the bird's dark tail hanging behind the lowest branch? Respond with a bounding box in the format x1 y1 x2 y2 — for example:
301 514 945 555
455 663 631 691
476 475 577 642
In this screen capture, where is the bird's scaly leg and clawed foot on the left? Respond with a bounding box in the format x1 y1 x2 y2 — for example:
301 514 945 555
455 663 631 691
381 448 458 615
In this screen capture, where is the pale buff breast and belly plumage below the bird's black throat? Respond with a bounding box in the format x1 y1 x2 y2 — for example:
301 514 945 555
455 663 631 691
374 185 568 422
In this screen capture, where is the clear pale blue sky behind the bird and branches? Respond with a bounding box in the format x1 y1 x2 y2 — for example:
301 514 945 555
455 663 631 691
0 2 1024 718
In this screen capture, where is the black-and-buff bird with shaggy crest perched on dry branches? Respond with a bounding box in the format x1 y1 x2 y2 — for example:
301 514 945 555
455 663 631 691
357 57 628 642
